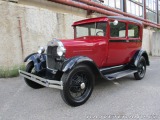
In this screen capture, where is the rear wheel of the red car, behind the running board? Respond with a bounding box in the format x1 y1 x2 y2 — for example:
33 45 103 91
134 56 146 80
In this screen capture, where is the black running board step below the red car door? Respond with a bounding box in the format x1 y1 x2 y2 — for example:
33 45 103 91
104 70 137 80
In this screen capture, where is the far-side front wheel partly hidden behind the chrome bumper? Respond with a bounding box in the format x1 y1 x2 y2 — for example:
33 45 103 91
24 62 44 89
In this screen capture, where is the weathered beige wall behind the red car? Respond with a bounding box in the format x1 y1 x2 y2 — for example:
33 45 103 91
0 0 156 67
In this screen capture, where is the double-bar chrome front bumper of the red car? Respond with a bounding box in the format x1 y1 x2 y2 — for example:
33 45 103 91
19 70 63 90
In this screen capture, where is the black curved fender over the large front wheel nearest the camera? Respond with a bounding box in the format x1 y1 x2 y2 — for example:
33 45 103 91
61 56 103 79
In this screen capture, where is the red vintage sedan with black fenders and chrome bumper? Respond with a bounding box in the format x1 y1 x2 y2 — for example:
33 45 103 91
19 16 149 106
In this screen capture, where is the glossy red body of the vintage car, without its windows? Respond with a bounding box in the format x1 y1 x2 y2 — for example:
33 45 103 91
61 17 143 68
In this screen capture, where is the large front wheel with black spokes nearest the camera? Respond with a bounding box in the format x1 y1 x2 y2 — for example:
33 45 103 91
61 65 95 106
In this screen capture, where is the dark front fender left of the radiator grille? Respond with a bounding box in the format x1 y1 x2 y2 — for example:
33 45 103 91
24 53 46 72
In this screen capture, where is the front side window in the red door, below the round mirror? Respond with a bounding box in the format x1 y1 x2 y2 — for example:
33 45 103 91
110 22 126 37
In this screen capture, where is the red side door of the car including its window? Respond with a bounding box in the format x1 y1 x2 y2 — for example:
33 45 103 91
107 21 128 66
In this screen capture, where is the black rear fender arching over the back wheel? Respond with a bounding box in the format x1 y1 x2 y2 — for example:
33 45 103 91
131 49 150 67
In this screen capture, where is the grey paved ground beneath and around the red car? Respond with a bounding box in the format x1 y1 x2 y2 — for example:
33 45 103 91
0 57 160 120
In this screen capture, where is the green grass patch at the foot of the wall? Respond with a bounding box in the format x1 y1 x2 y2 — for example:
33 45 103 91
0 65 25 78
